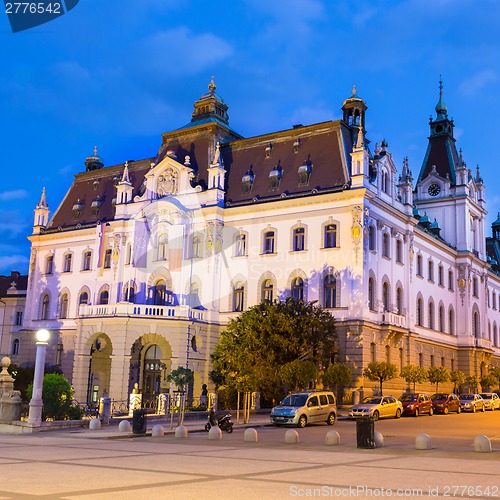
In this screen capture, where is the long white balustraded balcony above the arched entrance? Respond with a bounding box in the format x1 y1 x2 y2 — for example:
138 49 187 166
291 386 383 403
78 302 205 321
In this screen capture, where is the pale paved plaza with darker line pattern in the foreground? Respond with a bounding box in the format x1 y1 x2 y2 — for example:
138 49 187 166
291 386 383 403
0 419 500 500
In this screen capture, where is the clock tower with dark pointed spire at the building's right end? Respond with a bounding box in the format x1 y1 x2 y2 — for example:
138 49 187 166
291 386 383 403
414 81 486 259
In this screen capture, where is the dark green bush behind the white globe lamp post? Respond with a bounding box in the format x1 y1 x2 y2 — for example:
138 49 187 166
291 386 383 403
26 373 73 420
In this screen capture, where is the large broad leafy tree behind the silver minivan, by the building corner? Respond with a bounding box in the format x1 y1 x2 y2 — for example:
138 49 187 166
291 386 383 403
210 297 337 399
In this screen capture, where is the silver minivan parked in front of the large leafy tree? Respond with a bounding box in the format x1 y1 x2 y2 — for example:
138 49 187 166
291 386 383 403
270 391 337 427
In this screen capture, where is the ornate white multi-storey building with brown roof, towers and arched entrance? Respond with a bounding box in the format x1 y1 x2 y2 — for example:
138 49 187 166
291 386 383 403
16 80 500 401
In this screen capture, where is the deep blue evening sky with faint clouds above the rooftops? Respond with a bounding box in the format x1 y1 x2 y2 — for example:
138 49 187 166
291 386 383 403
0 0 500 274
